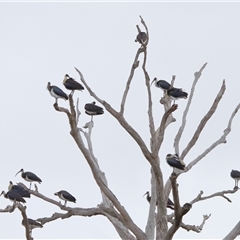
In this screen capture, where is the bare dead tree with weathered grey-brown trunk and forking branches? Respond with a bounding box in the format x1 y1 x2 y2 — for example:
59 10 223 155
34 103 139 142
0 15 240 240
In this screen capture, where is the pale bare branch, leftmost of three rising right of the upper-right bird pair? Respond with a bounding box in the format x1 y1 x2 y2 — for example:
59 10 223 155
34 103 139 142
174 63 207 155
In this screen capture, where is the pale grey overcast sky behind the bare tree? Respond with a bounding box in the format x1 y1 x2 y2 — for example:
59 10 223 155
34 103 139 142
0 2 240 239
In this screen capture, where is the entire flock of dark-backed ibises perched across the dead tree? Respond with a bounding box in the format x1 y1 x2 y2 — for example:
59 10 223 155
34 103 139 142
0 32 240 236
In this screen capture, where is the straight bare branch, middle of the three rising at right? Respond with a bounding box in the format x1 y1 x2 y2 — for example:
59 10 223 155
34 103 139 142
180 80 226 159
